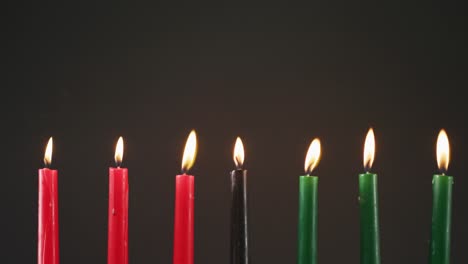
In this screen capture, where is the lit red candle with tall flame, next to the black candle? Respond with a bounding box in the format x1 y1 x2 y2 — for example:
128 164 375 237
173 130 197 264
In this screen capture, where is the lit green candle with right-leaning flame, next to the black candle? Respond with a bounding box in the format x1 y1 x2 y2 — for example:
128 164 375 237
297 138 321 264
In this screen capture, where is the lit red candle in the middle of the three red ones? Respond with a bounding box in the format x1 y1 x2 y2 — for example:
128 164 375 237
107 137 128 264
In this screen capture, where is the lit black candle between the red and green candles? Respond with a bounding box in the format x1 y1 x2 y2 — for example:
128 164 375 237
231 138 249 264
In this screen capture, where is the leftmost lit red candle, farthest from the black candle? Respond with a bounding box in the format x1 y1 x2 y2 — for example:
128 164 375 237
37 138 59 264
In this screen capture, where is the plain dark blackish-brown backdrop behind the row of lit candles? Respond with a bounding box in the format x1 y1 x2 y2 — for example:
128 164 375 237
4 1 468 264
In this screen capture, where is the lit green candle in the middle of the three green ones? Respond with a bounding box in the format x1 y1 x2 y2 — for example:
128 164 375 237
359 128 380 264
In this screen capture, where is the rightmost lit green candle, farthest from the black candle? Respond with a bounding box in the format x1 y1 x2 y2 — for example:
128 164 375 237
430 129 453 264
